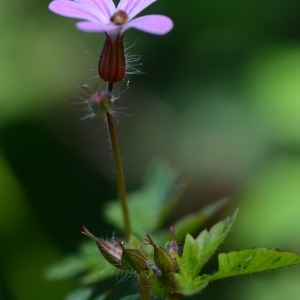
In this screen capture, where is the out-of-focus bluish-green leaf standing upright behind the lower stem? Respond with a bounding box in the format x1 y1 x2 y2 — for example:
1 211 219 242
104 162 180 238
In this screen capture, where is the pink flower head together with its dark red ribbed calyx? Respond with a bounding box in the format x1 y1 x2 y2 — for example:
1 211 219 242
49 0 173 84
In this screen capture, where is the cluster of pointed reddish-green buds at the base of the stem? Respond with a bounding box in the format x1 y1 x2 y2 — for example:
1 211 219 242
82 227 178 296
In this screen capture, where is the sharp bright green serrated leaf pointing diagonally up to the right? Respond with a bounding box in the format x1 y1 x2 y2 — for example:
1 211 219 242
178 209 238 279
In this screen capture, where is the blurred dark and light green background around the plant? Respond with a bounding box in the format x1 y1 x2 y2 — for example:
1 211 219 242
0 0 300 300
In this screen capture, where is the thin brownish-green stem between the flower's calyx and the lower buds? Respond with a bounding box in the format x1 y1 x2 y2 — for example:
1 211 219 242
106 83 131 238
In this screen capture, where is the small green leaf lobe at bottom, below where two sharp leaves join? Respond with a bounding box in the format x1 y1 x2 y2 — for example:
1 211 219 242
175 274 209 296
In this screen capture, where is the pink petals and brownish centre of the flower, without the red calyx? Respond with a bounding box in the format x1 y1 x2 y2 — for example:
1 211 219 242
49 0 173 36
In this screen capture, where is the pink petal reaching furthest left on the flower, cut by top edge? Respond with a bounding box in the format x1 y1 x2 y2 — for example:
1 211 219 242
49 0 104 22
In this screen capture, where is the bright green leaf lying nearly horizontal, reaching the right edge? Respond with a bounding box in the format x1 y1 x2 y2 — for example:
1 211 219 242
210 249 300 280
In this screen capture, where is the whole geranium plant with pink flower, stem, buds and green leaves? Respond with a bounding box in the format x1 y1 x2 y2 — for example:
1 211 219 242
47 0 300 300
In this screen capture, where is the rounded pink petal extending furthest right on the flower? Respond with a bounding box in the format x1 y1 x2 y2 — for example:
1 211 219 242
122 15 173 35
